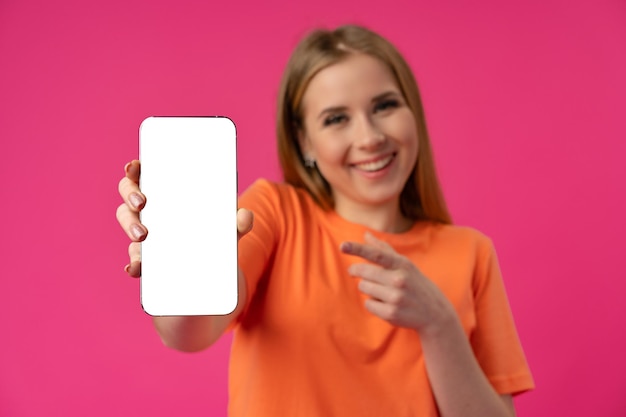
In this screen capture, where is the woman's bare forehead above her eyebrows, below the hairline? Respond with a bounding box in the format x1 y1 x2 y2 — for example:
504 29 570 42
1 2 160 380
302 54 400 112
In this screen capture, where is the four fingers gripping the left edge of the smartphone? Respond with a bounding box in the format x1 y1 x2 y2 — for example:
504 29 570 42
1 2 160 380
116 160 148 278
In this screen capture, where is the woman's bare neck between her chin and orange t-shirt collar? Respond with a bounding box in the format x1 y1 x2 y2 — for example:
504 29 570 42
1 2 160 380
335 199 413 233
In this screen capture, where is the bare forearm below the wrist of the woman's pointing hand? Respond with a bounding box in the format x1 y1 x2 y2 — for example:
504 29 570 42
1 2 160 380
420 314 515 417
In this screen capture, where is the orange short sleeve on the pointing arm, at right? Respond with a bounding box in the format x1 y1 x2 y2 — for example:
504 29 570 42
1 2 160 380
470 238 534 394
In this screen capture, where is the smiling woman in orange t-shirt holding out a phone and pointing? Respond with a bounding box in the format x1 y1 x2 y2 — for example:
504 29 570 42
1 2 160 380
118 26 533 417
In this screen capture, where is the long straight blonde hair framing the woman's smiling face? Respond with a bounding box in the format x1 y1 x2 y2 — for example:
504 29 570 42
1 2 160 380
277 25 452 223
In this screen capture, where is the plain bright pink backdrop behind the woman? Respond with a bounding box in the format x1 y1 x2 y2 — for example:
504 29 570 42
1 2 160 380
0 0 626 417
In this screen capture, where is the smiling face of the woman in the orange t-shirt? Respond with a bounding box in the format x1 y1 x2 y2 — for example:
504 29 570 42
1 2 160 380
299 54 418 213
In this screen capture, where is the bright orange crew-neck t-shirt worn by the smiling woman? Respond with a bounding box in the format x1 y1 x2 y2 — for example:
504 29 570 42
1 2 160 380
229 180 533 417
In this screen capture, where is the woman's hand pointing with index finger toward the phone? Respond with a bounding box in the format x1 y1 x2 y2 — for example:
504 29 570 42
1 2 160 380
340 233 456 334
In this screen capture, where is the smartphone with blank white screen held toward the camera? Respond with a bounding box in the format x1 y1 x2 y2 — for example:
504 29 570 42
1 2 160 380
139 117 238 316
